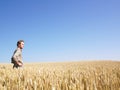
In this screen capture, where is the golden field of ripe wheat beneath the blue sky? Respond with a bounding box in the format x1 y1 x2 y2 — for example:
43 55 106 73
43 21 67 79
0 61 120 90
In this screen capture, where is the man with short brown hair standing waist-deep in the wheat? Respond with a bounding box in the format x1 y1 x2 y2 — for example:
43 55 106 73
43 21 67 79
11 40 24 69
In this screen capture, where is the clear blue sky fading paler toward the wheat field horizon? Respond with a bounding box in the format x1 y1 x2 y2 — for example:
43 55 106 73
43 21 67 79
0 0 120 62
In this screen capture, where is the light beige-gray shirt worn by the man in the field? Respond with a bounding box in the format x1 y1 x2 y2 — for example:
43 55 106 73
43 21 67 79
12 48 22 63
